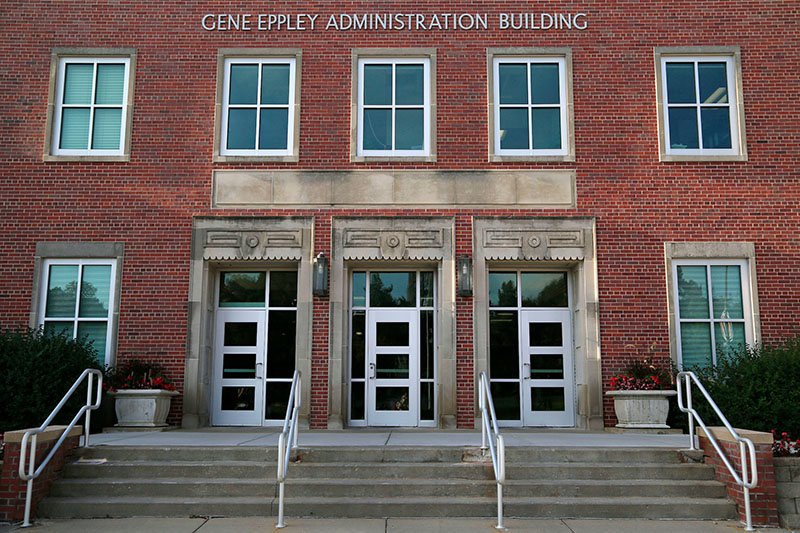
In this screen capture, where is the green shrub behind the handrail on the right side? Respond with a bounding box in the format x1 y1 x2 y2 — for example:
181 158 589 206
693 335 800 438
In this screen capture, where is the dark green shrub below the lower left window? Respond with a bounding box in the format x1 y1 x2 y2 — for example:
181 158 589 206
0 329 102 433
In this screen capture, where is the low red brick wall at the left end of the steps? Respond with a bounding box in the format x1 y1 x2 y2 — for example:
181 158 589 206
0 436 80 522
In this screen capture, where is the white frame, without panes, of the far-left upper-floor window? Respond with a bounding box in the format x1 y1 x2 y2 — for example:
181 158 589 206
51 56 131 156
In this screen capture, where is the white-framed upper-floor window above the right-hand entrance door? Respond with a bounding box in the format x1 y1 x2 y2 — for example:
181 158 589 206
492 55 570 156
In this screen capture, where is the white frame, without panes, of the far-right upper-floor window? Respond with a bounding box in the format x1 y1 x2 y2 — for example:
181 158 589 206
661 56 739 156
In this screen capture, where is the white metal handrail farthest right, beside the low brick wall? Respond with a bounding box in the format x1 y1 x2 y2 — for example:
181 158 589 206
678 371 758 531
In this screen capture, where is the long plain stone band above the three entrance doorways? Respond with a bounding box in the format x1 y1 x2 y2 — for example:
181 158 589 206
211 169 576 209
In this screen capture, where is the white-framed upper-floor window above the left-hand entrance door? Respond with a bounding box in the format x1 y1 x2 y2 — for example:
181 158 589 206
219 57 297 156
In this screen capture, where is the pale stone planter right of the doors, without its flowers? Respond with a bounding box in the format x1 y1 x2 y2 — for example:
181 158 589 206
606 390 678 429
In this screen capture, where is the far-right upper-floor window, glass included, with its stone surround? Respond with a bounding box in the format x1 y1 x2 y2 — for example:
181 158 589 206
658 47 745 160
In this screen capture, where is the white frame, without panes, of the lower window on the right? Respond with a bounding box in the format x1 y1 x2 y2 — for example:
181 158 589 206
671 259 755 369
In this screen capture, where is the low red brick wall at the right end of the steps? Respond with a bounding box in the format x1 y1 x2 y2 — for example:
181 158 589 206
699 437 780 526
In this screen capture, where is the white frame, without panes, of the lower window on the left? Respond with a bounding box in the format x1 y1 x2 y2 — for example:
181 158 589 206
37 259 117 366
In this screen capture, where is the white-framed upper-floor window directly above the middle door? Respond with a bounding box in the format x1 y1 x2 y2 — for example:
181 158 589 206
356 57 432 157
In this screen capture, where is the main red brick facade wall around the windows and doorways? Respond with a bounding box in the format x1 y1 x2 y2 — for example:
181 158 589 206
0 0 800 427
